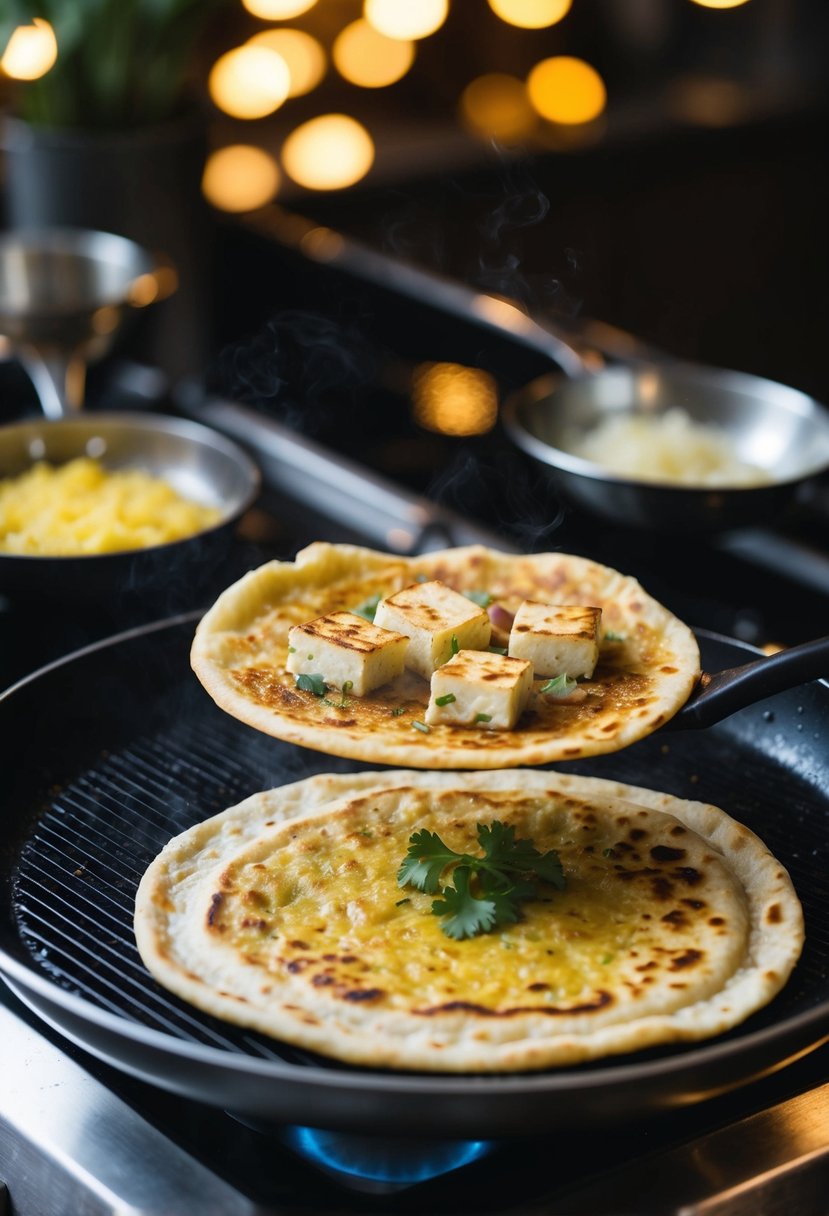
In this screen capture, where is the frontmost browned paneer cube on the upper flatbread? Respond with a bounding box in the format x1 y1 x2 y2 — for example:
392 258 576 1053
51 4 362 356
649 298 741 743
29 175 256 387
425 651 532 731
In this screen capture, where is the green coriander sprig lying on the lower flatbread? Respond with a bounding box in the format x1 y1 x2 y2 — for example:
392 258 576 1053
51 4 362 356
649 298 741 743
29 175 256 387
397 820 564 941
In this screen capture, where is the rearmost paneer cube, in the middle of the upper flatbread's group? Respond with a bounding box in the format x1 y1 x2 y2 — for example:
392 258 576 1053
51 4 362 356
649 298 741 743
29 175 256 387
374 579 492 680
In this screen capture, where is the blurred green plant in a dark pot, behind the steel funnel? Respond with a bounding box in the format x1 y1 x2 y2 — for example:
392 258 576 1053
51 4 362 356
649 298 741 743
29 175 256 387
0 0 229 373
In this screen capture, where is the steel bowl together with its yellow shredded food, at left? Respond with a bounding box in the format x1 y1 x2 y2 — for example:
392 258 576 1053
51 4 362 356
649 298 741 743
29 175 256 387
0 412 260 599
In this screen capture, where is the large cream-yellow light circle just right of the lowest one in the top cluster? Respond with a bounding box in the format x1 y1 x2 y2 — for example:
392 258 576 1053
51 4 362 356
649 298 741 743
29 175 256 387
282 114 374 190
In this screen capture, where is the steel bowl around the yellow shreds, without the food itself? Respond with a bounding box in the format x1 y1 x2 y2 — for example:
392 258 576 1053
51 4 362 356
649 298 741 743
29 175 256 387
0 412 260 606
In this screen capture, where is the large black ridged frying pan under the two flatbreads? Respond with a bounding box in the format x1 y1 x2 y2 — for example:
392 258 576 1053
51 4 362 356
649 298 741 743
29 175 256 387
0 614 829 1138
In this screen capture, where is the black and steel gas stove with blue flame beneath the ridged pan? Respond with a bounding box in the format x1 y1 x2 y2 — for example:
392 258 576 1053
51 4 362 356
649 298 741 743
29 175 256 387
0 173 829 1216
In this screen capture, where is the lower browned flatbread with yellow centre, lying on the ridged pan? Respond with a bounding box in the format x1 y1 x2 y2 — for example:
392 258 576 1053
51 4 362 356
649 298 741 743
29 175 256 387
135 770 803 1073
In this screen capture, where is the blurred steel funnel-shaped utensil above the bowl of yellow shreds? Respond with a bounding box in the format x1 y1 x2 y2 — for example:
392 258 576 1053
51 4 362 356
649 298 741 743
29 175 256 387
0 229 176 418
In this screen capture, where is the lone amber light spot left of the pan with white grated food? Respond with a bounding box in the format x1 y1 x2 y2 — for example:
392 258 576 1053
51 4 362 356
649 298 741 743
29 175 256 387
412 364 498 435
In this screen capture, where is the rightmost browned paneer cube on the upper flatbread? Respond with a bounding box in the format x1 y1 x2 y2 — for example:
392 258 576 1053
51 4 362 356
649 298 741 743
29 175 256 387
508 599 602 680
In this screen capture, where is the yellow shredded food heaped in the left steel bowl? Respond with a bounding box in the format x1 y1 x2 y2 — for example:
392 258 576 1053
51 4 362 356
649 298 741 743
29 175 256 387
0 456 220 557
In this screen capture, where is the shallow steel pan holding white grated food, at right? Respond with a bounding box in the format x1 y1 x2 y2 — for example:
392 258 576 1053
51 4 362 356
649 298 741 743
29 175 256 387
503 361 829 533
